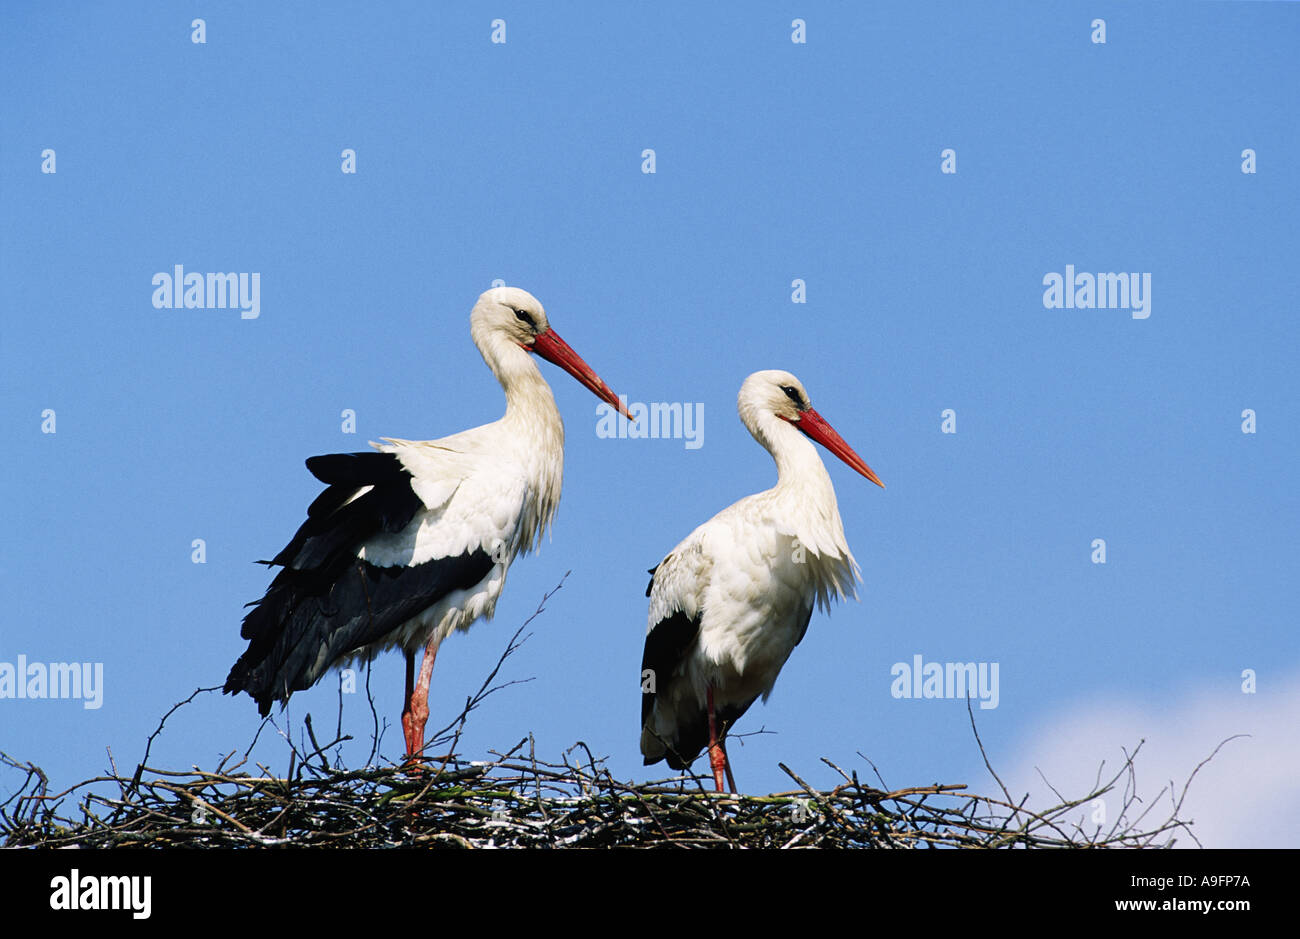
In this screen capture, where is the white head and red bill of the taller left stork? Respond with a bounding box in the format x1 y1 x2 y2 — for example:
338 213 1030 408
469 287 632 417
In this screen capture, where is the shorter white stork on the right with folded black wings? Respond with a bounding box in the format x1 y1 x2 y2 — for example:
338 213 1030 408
641 371 884 792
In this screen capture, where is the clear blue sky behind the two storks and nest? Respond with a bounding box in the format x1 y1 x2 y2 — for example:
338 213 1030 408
0 3 1300 845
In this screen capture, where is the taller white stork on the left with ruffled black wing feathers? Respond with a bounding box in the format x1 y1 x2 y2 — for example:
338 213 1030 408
225 287 631 758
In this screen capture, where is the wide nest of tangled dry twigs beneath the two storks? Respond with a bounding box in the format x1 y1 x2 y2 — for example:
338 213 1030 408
0 740 1184 848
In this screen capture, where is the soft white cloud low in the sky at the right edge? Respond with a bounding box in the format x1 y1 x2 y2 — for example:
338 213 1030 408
991 672 1300 848
